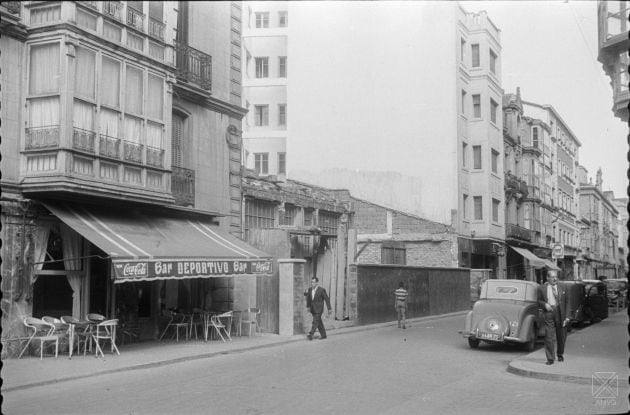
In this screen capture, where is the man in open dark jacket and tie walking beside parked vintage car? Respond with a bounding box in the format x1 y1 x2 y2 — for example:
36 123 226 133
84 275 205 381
538 270 571 365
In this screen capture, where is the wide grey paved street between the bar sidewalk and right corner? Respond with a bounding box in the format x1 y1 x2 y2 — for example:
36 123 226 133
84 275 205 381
3 316 619 415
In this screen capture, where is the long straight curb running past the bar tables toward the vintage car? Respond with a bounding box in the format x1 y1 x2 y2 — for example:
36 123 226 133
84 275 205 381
2 310 469 392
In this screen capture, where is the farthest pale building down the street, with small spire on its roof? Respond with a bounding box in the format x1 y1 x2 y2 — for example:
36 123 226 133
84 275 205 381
578 166 623 279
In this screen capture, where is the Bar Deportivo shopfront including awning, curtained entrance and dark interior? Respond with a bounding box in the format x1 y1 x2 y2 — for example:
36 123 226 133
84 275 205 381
2 200 274 356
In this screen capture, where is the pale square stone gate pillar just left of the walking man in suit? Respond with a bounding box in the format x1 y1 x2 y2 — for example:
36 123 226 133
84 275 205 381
278 259 306 336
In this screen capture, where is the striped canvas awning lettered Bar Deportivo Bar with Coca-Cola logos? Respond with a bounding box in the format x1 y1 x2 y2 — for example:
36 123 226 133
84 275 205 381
44 202 273 283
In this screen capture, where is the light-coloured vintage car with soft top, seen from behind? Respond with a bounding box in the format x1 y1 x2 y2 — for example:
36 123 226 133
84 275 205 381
460 280 545 351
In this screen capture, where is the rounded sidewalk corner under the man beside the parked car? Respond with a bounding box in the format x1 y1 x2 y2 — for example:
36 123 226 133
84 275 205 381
507 309 630 387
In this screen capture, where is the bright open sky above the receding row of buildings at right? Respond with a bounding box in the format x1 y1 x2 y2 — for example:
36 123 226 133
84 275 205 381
461 1 628 197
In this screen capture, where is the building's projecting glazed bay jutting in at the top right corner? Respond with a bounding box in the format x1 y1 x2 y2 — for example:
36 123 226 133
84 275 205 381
597 0 630 121
